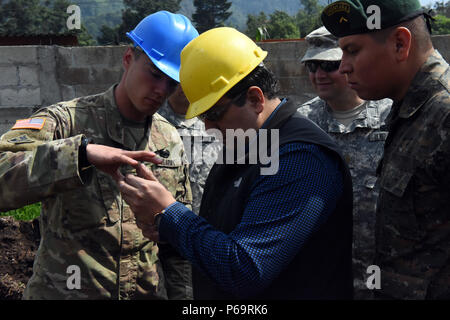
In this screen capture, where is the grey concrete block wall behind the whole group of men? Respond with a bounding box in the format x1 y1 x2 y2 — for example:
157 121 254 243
0 35 450 135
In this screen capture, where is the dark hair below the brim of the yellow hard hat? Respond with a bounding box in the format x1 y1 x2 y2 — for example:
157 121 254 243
225 63 279 106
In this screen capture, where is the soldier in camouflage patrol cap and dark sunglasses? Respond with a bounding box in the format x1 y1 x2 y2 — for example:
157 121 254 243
298 27 392 299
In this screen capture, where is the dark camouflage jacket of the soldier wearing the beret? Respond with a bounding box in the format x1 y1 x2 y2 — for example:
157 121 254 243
376 51 450 299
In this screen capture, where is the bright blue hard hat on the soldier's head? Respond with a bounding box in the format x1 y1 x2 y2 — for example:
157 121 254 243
127 11 198 82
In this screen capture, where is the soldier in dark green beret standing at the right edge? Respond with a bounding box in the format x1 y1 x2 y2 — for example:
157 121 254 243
322 0 450 299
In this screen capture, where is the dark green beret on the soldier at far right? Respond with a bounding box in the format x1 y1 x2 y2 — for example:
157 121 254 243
321 0 424 37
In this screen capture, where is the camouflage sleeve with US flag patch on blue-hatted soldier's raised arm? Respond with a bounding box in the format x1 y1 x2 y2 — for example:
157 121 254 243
0 107 91 211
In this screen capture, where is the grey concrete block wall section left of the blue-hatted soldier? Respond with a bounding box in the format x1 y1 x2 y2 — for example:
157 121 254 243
0 46 126 135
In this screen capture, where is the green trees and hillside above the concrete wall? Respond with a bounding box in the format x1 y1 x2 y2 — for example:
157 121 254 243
0 0 450 45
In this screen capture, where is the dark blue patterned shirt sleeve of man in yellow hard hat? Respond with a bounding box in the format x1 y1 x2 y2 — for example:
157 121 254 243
159 142 343 297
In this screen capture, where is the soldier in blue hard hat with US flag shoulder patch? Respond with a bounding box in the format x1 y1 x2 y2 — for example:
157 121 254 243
0 11 198 299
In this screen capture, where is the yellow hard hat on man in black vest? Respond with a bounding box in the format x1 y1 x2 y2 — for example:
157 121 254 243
180 27 267 119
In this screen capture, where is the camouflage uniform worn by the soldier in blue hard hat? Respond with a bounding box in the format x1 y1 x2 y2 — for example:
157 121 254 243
0 87 192 299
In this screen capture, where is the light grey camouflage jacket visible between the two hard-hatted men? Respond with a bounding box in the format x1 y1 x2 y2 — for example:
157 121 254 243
158 101 221 214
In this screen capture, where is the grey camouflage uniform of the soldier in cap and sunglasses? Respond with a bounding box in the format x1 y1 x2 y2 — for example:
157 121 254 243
298 97 392 299
